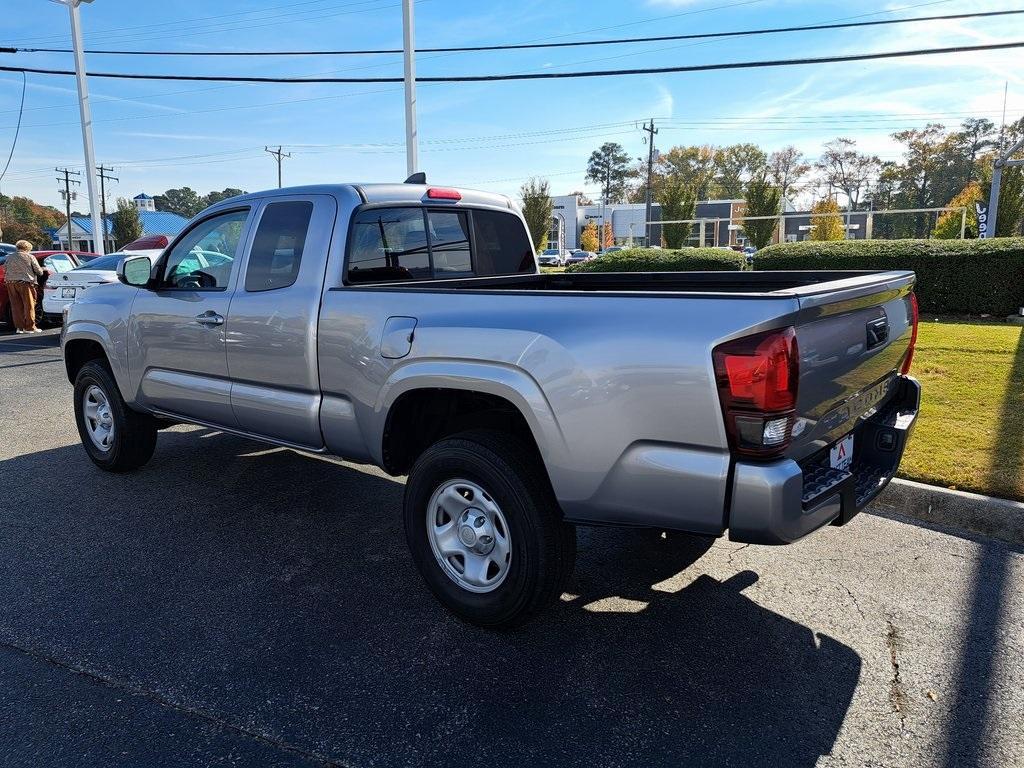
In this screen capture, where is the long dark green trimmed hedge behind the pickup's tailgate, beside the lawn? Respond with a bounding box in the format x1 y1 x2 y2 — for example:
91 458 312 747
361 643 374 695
754 238 1024 315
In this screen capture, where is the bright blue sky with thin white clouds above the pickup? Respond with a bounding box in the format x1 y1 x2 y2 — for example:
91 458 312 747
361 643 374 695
0 0 1024 210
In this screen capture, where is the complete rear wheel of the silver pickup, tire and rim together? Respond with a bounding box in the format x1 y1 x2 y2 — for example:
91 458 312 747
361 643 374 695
404 430 575 629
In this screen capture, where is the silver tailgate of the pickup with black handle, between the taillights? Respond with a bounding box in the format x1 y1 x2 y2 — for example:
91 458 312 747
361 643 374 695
786 271 914 461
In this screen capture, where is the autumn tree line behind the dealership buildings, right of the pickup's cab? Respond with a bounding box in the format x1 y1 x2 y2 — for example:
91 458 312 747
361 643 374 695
573 118 1024 247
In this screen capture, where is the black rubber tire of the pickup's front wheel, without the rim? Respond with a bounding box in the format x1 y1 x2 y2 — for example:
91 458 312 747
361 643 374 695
75 360 157 472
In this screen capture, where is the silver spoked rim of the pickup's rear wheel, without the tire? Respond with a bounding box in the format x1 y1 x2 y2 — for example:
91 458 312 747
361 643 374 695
427 480 512 593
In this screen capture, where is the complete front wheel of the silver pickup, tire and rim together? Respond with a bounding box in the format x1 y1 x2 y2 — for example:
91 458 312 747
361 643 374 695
75 360 157 472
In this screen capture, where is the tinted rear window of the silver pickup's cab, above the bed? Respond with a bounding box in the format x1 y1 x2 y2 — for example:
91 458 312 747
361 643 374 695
345 206 535 285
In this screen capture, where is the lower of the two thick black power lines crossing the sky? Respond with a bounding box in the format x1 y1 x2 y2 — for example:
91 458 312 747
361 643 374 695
0 40 1024 84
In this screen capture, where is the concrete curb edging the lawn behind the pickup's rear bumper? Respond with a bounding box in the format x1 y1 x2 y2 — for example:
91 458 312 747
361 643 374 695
867 478 1024 544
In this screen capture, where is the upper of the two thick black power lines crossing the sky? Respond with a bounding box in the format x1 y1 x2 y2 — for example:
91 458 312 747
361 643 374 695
12 8 1024 56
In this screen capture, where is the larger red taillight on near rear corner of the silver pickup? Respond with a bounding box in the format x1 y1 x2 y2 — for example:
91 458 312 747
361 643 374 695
713 327 800 458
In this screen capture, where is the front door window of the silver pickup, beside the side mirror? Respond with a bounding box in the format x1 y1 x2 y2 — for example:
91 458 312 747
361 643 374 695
161 210 249 291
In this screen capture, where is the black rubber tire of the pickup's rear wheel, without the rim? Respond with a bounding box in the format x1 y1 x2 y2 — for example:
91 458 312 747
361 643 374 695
404 430 575 629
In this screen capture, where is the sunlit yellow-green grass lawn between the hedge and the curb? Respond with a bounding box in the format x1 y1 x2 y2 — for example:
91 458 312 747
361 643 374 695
900 317 1024 501
